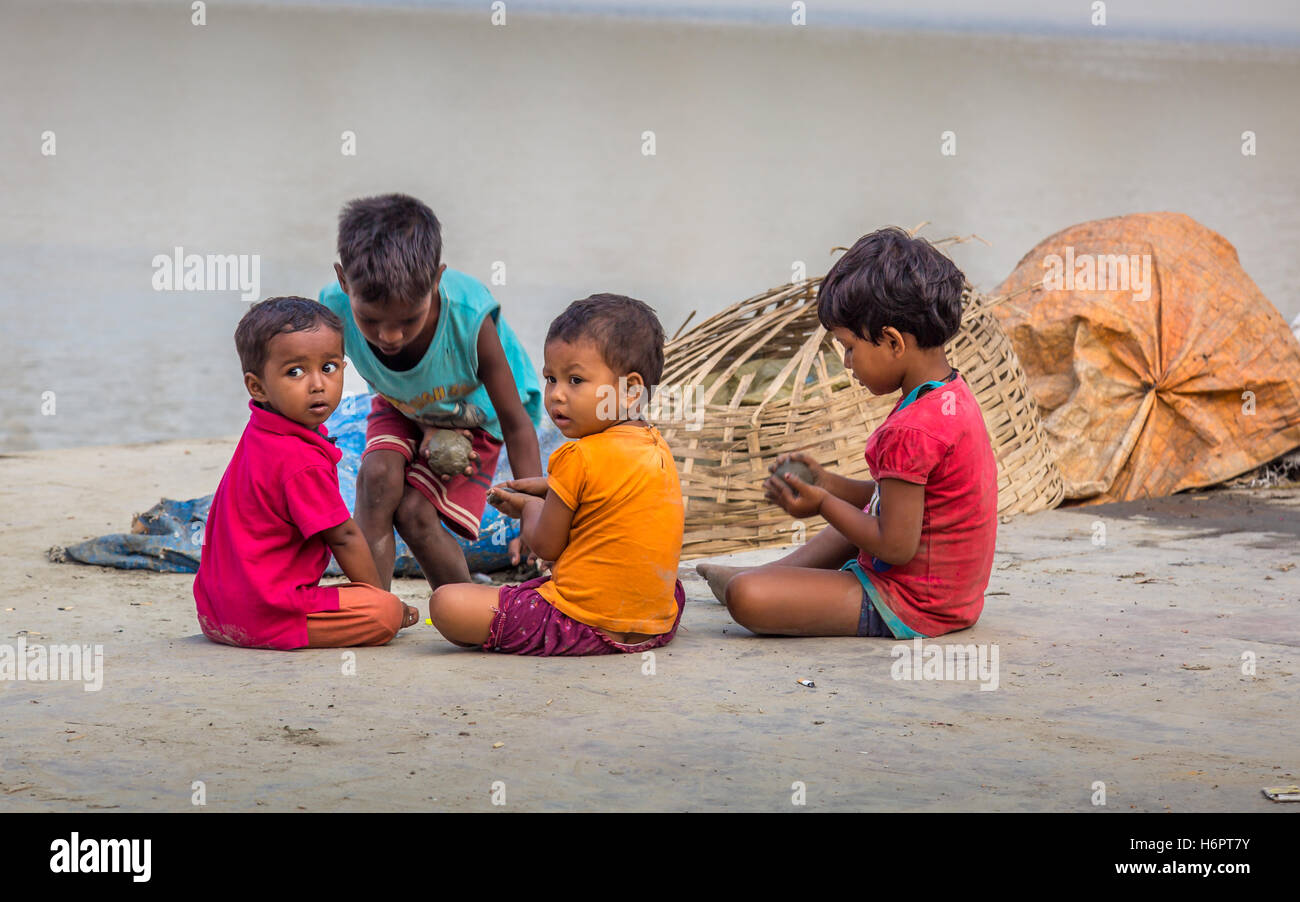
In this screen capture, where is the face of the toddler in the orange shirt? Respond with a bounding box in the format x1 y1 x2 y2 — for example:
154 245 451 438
542 339 642 438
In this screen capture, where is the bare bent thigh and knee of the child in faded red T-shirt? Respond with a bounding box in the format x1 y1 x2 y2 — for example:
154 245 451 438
727 564 862 636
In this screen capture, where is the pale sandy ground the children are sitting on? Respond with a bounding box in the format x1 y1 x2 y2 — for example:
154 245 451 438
0 441 1300 811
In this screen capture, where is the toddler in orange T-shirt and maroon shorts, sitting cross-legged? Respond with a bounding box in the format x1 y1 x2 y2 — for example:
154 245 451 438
429 294 686 655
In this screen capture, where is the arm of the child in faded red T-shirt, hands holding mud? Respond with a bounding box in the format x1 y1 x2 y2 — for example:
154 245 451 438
768 473 926 565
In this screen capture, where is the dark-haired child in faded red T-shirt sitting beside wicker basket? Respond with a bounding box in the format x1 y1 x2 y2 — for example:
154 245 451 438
698 229 997 638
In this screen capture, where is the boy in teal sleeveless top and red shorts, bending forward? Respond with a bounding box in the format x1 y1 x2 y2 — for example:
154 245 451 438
320 194 542 589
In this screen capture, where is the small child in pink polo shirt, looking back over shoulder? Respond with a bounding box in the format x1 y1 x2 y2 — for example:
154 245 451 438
194 298 419 649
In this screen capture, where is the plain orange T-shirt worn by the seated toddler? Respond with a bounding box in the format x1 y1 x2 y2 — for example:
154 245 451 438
537 424 685 636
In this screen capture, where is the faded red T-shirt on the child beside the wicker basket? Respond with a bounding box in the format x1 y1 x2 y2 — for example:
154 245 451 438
858 374 997 637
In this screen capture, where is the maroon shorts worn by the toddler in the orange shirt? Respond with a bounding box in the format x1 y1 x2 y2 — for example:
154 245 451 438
482 576 686 655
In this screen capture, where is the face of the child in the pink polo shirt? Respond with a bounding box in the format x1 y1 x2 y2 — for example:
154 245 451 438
244 326 343 429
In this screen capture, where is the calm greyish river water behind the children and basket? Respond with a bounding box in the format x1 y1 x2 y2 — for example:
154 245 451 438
0 3 1300 451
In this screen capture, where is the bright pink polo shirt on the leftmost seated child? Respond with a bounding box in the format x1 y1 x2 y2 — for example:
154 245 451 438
194 400 351 649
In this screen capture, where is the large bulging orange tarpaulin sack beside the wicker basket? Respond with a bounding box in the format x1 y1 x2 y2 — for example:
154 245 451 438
992 213 1300 503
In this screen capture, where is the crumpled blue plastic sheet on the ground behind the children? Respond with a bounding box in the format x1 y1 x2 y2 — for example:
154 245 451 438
51 394 564 577
